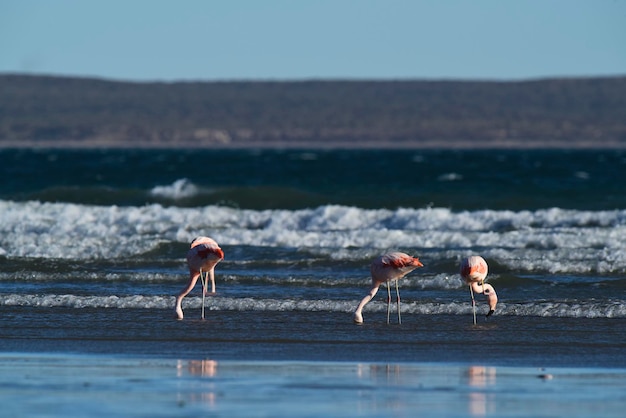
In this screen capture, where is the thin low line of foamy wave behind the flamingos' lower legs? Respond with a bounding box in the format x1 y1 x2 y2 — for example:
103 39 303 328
0 294 626 320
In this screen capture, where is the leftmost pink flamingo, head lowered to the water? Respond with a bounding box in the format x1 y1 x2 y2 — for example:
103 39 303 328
176 237 224 319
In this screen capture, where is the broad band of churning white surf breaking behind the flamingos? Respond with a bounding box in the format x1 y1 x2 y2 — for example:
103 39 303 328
0 201 626 273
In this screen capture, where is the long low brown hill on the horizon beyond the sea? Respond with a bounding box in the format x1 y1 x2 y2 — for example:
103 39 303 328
0 75 626 148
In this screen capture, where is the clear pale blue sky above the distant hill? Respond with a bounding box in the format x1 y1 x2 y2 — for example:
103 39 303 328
0 0 626 81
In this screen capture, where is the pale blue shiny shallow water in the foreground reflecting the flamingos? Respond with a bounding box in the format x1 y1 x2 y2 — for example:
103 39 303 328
0 355 626 417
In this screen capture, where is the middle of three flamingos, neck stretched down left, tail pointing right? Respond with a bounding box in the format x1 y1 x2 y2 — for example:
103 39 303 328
354 252 424 324
